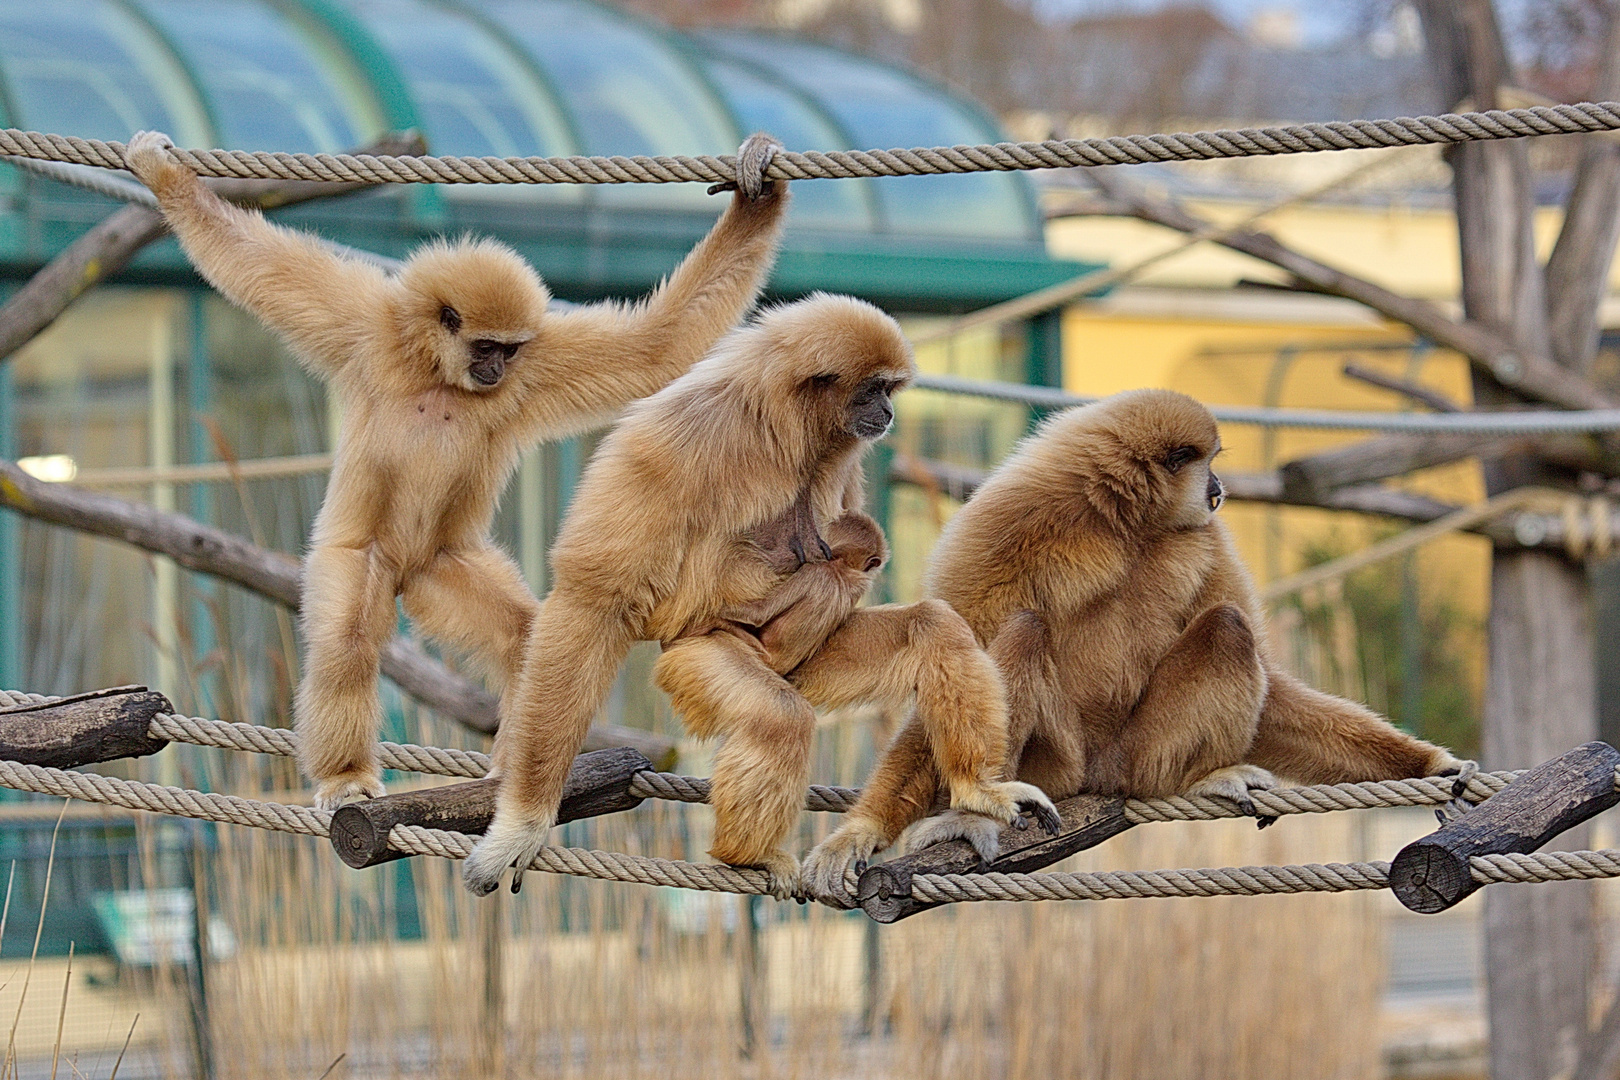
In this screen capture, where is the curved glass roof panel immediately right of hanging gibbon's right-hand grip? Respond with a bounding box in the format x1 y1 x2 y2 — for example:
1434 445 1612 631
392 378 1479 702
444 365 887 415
708 55 875 232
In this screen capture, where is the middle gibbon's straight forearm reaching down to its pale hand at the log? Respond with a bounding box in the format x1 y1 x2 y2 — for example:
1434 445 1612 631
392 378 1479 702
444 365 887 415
462 588 635 895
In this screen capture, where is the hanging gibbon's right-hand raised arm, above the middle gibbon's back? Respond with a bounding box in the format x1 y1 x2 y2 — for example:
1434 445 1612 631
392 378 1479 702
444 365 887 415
515 183 787 432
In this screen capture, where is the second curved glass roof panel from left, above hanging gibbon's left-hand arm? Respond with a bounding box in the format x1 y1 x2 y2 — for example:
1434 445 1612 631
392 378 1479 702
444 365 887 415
133 0 379 154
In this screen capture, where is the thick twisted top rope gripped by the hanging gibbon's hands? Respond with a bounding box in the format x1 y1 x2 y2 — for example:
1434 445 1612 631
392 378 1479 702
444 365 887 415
9 102 1620 183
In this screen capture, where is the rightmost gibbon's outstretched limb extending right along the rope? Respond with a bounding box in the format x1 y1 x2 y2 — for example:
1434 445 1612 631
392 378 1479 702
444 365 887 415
1244 670 1461 784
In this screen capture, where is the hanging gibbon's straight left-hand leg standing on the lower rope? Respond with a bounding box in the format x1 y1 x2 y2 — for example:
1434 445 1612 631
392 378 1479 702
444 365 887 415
293 547 397 810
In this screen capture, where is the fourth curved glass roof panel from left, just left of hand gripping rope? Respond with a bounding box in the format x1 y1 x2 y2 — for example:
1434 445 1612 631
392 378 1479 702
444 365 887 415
484 0 740 209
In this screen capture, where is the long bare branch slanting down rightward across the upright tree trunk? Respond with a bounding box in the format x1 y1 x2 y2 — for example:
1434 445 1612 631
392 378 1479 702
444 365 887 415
1087 168 1617 408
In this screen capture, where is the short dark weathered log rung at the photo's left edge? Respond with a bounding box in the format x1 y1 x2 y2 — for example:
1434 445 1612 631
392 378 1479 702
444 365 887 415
0 687 173 769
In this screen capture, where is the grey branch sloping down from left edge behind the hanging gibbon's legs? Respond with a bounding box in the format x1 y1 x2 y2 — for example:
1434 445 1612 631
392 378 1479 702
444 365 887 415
0 460 676 767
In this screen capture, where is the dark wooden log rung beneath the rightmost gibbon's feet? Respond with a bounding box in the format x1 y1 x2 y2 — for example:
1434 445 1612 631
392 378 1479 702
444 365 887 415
855 795 1132 923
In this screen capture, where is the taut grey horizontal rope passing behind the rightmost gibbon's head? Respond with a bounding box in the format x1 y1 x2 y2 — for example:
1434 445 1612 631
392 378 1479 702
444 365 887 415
910 376 1620 436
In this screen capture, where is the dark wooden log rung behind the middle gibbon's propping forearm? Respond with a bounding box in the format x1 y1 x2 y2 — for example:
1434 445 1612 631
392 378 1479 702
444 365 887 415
330 746 653 870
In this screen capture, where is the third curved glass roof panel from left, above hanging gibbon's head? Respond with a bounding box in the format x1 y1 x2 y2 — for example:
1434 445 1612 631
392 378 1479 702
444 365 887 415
341 0 585 202
